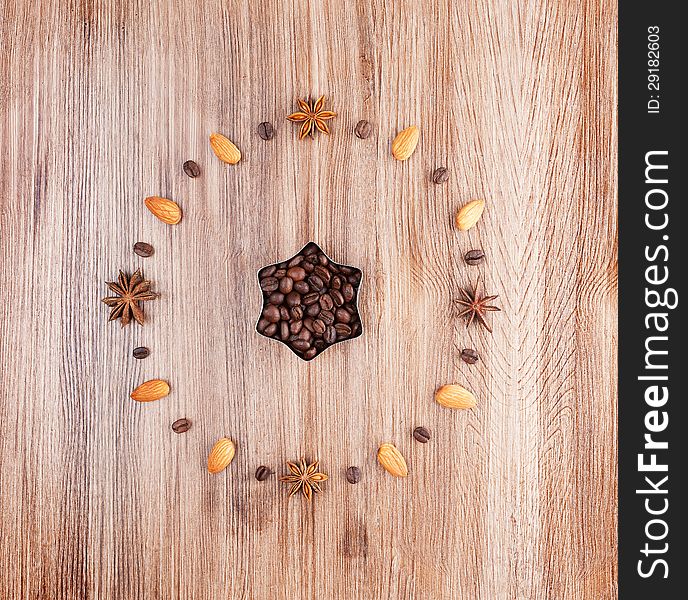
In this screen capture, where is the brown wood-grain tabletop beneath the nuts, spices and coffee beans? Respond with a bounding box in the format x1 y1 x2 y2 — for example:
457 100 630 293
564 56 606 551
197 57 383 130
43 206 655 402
0 0 617 600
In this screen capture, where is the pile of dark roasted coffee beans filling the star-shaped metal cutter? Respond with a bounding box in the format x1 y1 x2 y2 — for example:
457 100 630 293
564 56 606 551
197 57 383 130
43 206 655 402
256 242 363 360
